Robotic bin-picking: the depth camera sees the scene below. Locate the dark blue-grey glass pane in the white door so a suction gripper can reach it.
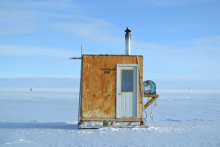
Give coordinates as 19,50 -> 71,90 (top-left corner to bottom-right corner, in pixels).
121,70 -> 134,92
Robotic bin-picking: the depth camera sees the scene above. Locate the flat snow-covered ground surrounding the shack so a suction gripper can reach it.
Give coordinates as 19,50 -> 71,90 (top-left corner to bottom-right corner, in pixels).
0,88 -> 220,147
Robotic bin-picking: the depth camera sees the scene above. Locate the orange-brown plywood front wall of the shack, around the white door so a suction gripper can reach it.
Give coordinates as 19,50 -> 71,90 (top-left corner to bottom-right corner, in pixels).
82,55 -> 143,119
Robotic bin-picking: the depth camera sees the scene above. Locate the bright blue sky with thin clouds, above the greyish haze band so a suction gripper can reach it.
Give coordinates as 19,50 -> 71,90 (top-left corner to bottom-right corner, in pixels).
0,0 -> 220,84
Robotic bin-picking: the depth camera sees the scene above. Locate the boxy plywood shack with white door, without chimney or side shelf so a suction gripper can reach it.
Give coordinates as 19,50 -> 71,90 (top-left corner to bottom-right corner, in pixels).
78,54 -> 144,128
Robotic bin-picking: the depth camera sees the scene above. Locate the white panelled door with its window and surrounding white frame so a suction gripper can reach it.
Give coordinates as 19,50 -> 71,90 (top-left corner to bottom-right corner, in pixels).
116,64 -> 139,118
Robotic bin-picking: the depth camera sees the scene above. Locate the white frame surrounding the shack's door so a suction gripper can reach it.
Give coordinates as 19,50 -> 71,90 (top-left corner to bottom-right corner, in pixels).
115,64 -> 139,118
